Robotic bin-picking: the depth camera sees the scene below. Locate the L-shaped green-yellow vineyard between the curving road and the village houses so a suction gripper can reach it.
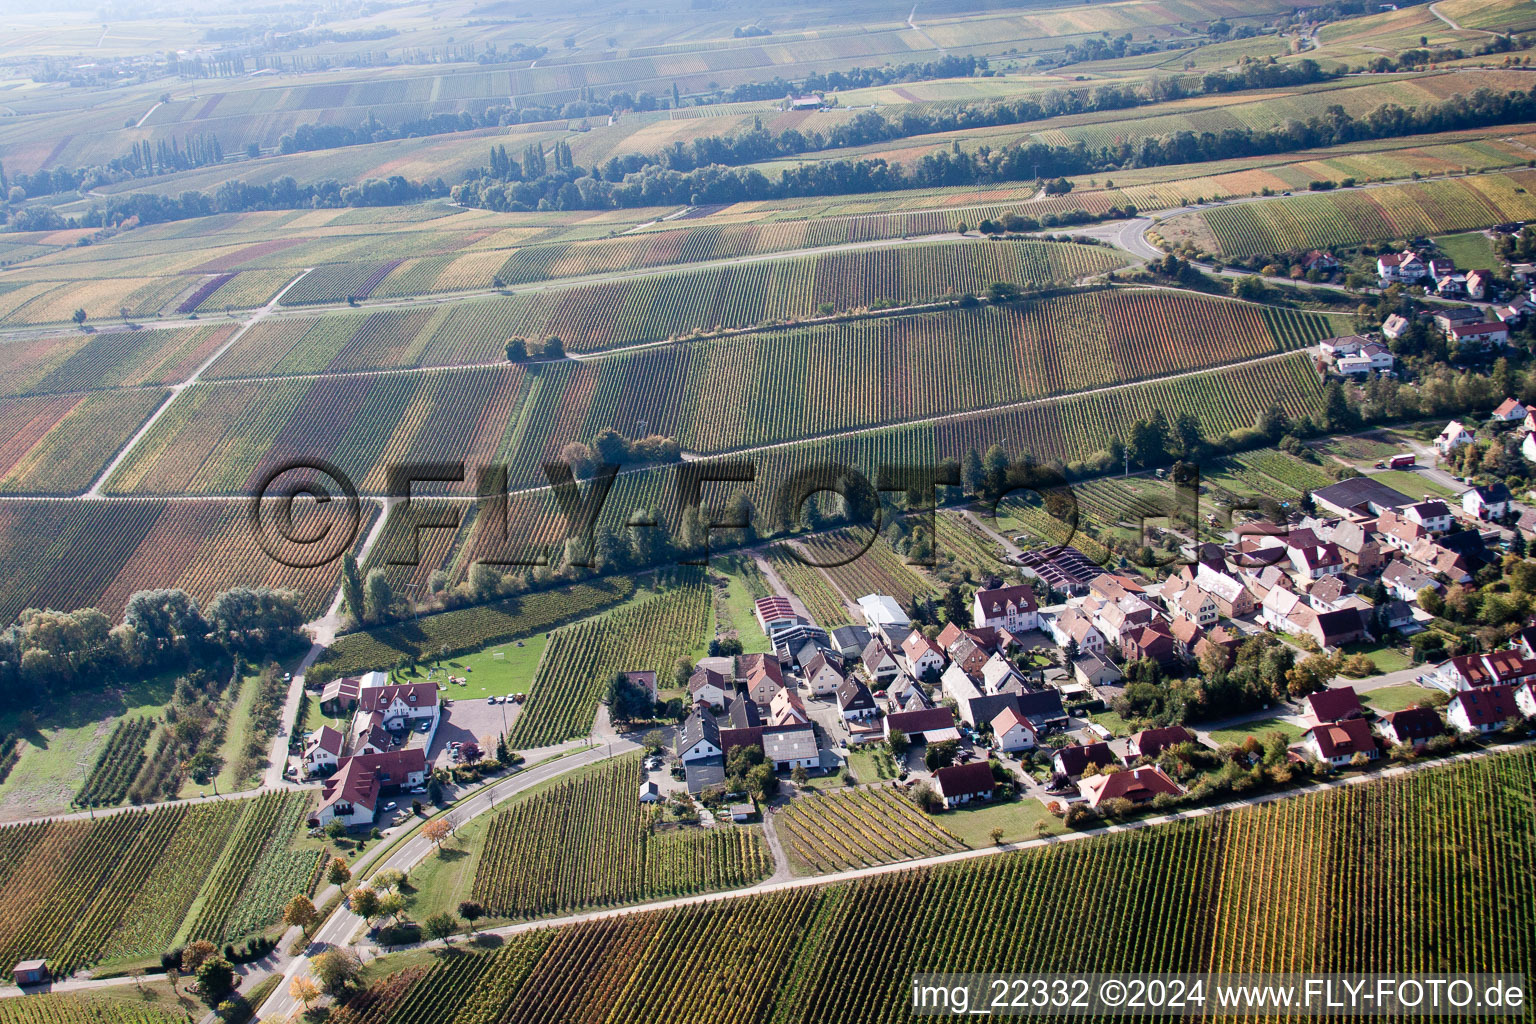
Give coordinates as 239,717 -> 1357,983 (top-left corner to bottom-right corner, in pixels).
472,755 -> 773,918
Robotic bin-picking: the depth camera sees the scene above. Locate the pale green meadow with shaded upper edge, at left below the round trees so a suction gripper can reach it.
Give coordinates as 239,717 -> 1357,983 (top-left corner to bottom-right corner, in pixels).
0,672 -> 180,820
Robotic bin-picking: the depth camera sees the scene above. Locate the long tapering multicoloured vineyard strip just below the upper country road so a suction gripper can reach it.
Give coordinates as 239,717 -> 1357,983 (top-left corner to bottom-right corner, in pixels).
209,243 -> 1124,378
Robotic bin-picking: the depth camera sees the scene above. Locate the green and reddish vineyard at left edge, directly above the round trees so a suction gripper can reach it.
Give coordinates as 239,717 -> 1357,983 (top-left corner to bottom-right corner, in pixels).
0,499 -> 378,622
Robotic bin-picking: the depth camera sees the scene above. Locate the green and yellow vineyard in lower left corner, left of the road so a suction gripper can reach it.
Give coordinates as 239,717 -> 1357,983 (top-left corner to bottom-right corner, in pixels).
0,792 -> 319,973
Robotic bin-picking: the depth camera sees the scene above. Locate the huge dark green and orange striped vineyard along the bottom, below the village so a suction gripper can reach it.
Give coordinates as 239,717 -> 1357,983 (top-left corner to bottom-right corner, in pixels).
339,751 -> 1536,1024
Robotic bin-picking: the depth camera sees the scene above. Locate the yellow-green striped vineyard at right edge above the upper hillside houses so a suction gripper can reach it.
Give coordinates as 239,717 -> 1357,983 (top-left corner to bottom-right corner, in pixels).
1158,170 -> 1536,256
